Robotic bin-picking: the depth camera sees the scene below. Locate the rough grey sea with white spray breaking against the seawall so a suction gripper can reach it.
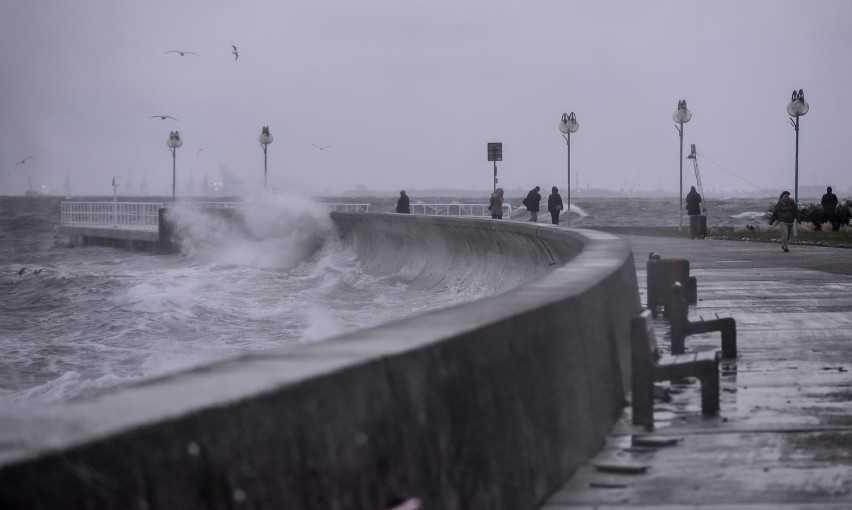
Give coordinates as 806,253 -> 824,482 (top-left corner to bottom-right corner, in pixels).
0,195 -> 773,412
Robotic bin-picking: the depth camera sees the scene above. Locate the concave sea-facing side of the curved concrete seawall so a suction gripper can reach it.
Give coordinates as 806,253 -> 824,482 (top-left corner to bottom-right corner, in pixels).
332,213 -> 583,291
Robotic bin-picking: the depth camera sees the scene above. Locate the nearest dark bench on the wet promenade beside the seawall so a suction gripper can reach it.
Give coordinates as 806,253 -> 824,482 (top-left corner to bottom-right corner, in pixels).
630,310 -> 719,429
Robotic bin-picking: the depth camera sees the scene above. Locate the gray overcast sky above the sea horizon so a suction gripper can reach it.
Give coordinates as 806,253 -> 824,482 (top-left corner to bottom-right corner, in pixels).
0,0 -> 852,196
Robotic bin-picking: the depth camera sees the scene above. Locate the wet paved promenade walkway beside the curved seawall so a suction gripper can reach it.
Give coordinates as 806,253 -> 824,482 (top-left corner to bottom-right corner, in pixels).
542,236 -> 852,510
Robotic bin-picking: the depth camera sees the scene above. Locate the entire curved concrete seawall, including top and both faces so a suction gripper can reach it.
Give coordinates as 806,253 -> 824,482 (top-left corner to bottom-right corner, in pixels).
0,213 -> 640,510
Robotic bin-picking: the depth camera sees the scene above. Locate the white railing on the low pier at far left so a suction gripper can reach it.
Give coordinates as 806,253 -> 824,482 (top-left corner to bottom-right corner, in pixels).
61,202 -> 163,230
